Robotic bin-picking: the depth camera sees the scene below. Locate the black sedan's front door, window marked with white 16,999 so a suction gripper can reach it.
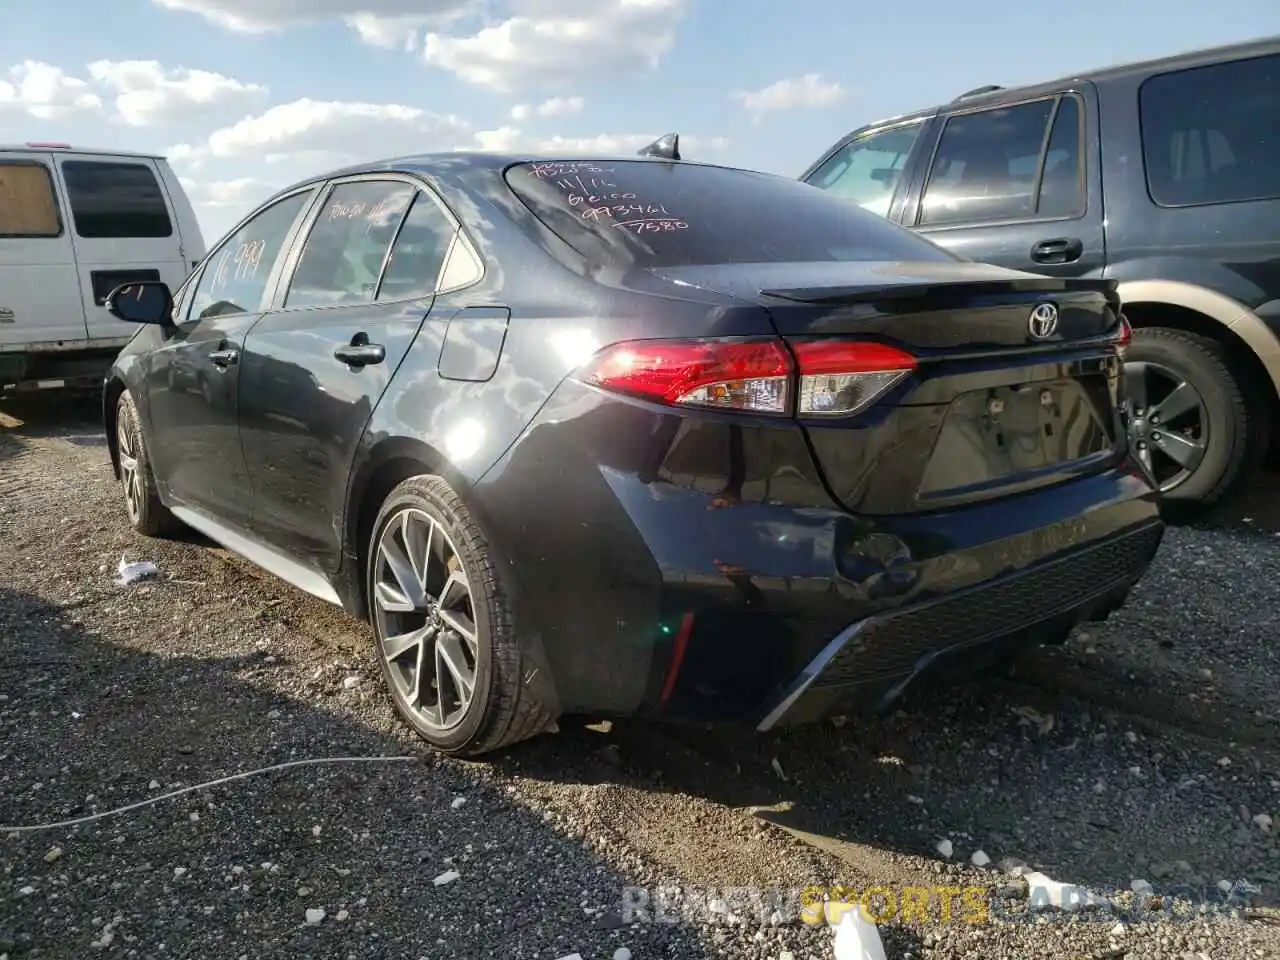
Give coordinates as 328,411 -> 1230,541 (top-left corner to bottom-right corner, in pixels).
147,189 -> 314,530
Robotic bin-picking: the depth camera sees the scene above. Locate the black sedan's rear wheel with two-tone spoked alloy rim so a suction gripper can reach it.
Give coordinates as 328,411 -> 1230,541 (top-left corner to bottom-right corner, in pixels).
366,476 -> 554,756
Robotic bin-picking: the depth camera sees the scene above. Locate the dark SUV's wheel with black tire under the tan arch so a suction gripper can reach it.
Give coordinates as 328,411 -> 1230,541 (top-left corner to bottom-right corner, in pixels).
1125,326 -> 1270,509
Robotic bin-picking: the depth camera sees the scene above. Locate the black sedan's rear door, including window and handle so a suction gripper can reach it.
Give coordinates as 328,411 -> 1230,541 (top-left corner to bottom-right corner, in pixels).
239,174 -> 456,571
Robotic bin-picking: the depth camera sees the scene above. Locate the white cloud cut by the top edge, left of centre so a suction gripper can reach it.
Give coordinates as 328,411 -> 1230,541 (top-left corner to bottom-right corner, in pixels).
152,0 -> 477,47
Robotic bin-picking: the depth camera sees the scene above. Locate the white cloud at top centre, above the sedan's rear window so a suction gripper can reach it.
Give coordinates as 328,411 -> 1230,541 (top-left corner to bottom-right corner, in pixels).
424,0 -> 687,92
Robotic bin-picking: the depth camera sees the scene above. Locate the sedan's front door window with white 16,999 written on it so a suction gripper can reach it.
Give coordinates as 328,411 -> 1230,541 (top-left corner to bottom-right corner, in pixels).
188,191 -> 311,320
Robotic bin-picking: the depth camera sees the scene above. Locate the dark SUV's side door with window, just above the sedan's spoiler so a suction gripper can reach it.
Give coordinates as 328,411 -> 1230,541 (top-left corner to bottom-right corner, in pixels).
904,83 -> 1106,276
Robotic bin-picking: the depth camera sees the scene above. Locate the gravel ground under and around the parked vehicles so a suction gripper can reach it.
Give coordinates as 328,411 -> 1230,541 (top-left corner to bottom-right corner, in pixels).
0,397 -> 1280,960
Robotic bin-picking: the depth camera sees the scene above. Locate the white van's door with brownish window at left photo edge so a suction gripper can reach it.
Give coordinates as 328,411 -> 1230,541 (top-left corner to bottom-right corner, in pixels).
0,151 -> 87,350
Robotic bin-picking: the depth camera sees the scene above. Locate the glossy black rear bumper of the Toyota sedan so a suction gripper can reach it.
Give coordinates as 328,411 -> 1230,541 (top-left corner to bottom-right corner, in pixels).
472,387 -> 1162,726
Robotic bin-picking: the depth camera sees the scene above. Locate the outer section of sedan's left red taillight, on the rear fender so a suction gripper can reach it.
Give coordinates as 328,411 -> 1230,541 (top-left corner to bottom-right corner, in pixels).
581,339 -> 791,413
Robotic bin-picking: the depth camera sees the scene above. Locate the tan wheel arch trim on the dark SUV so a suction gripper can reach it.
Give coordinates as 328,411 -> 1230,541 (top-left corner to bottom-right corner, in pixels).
1119,280 -> 1280,442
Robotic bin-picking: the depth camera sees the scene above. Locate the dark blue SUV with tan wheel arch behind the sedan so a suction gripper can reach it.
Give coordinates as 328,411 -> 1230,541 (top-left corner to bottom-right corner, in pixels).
801,38 -> 1280,506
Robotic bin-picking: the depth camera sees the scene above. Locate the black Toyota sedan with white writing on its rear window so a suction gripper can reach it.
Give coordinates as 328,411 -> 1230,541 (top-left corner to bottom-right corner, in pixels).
104,144 -> 1162,754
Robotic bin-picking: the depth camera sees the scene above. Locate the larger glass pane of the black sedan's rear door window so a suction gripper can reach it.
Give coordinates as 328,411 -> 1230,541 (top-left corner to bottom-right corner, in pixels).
284,180 -> 414,307
